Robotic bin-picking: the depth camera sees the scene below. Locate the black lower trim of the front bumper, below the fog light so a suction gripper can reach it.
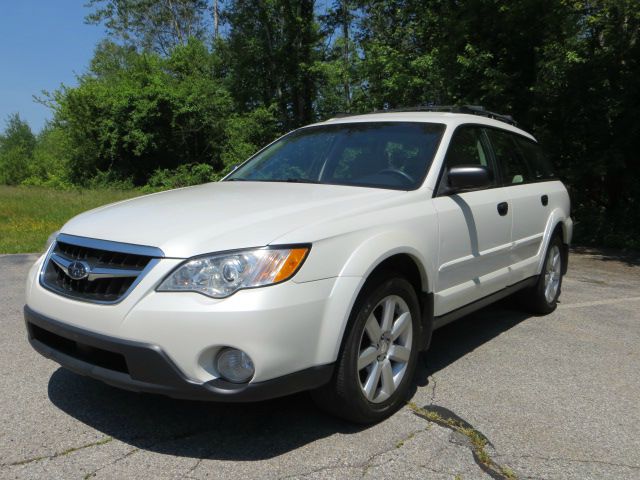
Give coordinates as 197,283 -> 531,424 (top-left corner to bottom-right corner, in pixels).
24,306 -> 334,402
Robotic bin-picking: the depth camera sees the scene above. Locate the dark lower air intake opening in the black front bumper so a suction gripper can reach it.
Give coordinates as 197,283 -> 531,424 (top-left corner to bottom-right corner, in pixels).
28,323 -> 129,374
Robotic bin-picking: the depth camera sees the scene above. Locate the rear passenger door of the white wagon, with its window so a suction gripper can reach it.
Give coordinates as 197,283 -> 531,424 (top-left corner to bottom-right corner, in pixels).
486,128 -> 550,283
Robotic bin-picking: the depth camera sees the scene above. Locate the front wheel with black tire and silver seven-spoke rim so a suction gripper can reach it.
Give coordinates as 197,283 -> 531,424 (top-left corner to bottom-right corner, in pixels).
312,273 -> 420,424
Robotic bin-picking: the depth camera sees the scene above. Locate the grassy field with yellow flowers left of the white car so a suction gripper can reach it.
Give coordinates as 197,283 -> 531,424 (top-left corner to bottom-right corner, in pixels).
0,185 -> 142,254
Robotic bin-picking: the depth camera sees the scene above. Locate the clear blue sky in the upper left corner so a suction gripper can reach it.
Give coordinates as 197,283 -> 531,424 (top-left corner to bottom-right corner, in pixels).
0,0 -> 104,132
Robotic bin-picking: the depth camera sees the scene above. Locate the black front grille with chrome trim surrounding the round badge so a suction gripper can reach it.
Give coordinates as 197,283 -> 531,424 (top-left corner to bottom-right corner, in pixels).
41,235 -> 162,303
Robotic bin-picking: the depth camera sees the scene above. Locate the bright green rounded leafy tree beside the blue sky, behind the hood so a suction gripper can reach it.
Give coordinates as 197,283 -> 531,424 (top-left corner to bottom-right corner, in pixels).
50,40 -> 232,185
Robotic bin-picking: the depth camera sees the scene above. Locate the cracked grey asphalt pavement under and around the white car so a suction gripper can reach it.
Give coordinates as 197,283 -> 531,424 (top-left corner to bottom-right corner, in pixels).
0,251 -> 640,480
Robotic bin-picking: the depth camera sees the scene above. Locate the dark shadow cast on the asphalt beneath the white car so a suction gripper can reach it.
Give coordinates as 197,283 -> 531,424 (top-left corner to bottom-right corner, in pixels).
48,298 -> 527,460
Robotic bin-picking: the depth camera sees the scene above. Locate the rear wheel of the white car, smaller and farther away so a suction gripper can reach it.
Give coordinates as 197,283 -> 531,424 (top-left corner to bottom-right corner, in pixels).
521,234 -> 564,315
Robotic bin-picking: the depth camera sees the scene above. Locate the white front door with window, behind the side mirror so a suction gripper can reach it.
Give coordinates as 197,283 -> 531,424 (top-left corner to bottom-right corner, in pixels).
433,125 -> 511,316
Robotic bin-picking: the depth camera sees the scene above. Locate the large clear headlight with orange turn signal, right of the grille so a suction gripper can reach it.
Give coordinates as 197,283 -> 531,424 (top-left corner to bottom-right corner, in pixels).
157,247 -> 309,298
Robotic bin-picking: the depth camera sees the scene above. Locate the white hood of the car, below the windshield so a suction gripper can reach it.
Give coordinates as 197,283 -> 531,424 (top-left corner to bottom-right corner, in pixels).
61,182 -> 406,258
